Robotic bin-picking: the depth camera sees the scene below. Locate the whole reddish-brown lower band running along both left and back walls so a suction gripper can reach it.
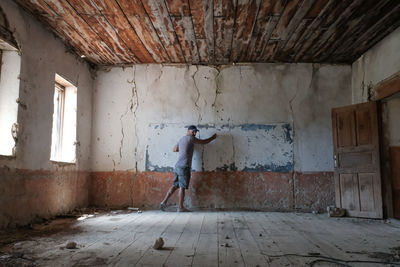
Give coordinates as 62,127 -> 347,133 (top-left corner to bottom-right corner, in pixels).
0,169 -> 334,228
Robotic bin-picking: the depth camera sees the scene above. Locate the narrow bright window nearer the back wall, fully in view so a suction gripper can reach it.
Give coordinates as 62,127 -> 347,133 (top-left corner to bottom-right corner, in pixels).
50,74 -> 77,163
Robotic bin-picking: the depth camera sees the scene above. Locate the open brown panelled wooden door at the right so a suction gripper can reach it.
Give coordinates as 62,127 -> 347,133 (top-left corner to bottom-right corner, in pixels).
332,102 -> 383,218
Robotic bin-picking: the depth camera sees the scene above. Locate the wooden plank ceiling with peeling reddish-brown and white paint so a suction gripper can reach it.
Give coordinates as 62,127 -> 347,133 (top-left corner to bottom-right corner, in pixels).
15,0 -> 400,65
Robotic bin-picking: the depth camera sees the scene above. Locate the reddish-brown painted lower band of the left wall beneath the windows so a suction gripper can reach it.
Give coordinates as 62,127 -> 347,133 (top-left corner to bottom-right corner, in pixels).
0,169 -> 89,228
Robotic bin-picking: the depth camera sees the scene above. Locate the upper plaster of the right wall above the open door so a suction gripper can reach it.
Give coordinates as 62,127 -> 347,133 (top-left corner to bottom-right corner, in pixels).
352,28 -> 400,104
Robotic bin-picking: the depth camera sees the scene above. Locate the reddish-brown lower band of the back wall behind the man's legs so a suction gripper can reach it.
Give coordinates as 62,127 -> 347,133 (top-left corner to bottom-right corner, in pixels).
89,171 -> 335,214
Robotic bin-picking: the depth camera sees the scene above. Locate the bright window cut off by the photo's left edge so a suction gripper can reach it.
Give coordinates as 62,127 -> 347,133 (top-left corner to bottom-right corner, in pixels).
0,39 -> 21,156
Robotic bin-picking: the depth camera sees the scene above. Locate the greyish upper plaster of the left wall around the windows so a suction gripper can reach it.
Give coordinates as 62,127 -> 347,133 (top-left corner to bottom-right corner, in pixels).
0,0 -> 93,170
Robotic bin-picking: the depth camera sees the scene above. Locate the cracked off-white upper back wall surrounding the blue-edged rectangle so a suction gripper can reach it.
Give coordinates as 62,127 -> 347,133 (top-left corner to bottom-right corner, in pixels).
91,64 -> 351,172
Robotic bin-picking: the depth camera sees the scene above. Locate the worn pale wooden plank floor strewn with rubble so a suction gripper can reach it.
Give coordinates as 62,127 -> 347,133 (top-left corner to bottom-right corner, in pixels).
0,211 -> 400,266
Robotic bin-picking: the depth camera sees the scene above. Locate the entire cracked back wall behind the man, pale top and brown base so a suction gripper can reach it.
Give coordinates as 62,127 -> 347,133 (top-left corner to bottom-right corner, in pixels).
90,64 -> 351,213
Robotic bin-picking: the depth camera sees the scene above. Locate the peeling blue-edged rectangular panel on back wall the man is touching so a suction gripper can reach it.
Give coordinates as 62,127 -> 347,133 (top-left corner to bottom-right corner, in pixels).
145,123 -> 293,172
